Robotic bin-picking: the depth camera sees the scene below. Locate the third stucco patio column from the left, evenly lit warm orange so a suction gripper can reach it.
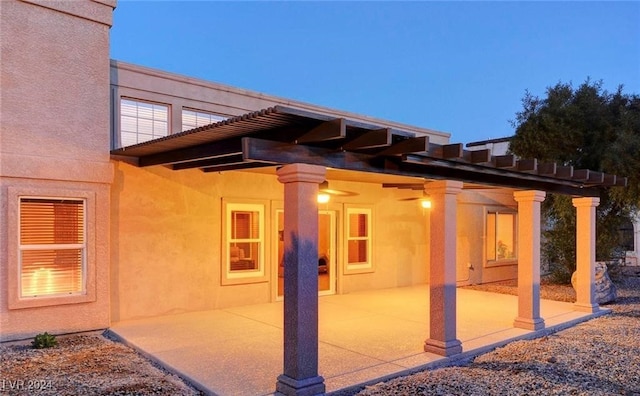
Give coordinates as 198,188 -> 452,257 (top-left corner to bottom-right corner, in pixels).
513,191 -> 546,330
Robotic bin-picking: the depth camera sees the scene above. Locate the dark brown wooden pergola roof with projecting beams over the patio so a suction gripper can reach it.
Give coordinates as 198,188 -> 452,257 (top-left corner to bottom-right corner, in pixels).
111,105 -> 626,196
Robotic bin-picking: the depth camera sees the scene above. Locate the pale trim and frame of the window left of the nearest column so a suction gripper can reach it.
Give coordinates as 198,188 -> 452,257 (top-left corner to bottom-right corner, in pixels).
220,199 -> 269,286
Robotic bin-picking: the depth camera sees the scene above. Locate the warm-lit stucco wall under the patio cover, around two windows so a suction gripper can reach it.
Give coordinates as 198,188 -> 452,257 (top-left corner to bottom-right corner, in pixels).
111,162 -> 436,321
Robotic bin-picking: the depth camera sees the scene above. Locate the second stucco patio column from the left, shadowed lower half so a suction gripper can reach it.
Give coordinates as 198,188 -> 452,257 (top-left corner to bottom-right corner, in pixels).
424,180 -> 462,356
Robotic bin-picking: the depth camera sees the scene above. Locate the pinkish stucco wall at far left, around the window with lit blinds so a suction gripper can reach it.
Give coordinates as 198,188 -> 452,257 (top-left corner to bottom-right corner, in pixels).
0,0 -> 115,340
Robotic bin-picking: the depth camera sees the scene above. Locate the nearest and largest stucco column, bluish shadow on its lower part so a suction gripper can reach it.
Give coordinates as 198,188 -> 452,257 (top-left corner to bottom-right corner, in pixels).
276,164 -> 326,396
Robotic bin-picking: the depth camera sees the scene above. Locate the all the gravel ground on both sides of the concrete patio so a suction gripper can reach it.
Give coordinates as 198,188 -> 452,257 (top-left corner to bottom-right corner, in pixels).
0,271 -> 640,396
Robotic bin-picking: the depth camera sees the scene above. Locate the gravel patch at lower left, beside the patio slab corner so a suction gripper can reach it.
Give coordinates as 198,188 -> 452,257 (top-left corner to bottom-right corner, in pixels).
0,334 -> 200,396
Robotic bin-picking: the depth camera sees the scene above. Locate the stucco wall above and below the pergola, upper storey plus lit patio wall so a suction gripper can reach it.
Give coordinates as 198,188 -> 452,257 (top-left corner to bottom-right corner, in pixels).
110,60 -> 460,321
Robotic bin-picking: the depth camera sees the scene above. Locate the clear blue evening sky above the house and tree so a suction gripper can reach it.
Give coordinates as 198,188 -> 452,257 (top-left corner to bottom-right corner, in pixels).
111,0 -> 640,143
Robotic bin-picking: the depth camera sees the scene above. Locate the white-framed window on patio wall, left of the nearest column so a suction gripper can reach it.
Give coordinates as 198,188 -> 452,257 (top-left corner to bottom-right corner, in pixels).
223,203 -> 265,283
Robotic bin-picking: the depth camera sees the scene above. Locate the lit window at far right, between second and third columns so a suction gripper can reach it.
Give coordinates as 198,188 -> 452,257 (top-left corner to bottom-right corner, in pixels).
487,212 -> 517,261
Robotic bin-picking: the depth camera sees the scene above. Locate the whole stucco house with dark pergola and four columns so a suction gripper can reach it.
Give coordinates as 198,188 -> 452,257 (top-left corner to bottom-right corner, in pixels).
0,0 -> 621,394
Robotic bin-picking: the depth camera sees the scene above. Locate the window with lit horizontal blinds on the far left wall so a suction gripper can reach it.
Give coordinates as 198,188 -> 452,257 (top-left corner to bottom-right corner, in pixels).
19,197 -> 86,298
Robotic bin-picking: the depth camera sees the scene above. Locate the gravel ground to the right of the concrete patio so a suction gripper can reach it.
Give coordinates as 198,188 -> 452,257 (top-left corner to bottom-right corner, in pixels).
358,272 -> 640,396
